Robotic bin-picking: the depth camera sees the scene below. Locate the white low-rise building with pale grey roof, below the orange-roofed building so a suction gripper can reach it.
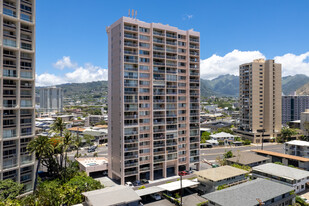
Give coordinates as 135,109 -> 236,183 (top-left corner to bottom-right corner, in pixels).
252,163 -> 309,193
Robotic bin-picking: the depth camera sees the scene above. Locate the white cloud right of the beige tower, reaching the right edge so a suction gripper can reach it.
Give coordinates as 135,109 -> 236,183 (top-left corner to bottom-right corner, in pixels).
274,52 -> 309,76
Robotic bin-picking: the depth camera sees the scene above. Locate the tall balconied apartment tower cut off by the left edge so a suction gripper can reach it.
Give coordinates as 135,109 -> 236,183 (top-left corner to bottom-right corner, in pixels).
0,0 -> 35,193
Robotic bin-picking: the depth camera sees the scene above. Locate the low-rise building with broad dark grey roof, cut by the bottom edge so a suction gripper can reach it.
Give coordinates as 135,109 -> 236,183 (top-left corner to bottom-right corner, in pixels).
202,179 -> 295,206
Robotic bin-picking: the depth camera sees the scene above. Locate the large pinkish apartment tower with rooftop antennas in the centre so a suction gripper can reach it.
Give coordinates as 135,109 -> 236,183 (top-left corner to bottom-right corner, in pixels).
107,17 -> 200,184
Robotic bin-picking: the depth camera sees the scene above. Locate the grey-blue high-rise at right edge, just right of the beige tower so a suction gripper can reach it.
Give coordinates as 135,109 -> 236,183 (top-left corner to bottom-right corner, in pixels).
282,95 -> 309,124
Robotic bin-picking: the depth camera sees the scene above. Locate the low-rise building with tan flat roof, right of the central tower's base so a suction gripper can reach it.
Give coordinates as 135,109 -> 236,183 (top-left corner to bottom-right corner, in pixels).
195,166 -> 248,193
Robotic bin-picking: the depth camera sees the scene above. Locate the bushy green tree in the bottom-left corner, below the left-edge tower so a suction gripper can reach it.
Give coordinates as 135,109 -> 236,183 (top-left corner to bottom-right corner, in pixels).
0,179 -> 23,202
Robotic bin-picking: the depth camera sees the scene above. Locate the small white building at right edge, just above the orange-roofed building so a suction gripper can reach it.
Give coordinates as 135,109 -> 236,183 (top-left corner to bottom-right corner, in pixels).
284,140 -> 309,158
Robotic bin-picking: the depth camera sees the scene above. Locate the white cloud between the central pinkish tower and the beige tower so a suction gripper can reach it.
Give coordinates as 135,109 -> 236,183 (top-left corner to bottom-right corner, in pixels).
200,49 -> 265,79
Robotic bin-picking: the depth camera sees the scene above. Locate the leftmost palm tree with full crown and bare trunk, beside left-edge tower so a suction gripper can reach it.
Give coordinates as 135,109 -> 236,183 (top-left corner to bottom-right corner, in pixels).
27,136 -> 53,192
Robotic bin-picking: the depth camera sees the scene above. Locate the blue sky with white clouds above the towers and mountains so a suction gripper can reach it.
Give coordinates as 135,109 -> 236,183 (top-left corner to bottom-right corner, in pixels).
36,0 -> 309,85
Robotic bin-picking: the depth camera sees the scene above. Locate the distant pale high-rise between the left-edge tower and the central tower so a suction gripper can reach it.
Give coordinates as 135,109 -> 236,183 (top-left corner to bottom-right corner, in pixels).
40,87 -> 63,112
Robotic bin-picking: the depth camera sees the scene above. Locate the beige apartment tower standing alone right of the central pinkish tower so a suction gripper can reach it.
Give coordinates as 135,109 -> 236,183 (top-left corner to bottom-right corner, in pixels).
237,59 -> 282,143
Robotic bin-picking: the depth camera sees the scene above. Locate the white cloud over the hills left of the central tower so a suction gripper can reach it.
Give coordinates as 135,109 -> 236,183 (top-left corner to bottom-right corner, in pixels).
36,57 -> 108,86
